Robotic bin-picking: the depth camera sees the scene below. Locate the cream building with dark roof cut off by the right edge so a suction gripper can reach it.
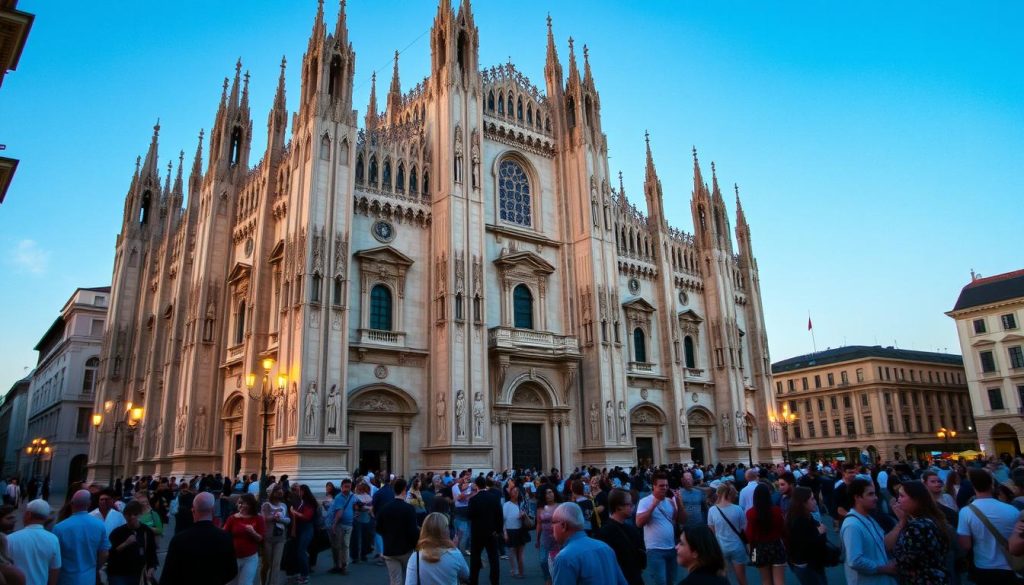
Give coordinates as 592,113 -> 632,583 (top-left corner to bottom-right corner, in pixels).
946,270 -> 1024,455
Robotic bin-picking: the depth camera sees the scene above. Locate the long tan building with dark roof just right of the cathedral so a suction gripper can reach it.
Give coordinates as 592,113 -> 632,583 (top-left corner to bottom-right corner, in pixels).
772,345 -> 978,461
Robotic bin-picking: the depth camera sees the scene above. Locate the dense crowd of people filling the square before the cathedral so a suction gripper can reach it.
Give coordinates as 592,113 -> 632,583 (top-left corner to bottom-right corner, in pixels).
6,458 -> 1024,585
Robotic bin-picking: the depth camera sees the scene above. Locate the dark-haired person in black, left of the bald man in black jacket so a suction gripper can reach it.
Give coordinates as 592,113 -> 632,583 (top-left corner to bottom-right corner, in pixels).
106,501 -> 158,585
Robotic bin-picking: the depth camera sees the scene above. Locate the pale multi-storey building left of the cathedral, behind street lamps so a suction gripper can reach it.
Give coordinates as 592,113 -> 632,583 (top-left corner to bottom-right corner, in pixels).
22,287 -> 111,494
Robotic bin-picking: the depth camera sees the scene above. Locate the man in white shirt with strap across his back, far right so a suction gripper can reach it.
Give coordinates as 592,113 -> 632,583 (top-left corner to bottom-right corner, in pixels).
956,469 -> 1021,585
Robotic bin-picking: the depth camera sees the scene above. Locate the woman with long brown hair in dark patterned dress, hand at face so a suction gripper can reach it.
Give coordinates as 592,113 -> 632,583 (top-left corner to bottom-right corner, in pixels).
886,480 -> 950,585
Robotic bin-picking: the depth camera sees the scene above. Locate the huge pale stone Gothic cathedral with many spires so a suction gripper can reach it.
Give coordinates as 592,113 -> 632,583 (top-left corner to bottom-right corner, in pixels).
89,0 -> 782,485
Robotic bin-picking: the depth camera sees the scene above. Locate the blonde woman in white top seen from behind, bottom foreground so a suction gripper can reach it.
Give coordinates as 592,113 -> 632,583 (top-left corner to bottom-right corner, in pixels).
406,512 -> 469,585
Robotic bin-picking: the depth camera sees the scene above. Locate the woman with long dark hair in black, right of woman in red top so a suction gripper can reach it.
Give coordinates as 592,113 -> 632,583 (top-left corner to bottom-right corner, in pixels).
785,486 -> 828,585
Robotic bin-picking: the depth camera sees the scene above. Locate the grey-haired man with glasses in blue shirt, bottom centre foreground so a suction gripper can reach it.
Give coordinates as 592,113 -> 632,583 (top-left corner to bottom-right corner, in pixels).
551,502 -> 627,585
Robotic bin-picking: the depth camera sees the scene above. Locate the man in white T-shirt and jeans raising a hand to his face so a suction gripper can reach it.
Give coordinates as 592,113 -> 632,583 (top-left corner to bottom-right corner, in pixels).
636,471 -> 686,585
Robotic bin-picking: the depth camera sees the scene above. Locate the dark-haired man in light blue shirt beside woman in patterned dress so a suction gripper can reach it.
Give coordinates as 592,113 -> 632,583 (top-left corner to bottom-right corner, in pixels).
836,477 -> 896,585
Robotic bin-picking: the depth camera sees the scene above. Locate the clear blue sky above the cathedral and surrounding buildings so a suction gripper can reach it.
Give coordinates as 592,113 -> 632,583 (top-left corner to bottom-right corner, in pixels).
0,0 -> 1024,391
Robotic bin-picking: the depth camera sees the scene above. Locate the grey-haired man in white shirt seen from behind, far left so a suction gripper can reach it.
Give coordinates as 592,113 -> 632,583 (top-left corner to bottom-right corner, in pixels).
7,500 -> 60,585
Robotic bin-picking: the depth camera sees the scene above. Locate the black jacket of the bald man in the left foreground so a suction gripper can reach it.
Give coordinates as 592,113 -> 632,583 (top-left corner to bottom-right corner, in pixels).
160,520 -> 239,585
